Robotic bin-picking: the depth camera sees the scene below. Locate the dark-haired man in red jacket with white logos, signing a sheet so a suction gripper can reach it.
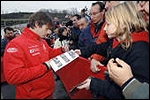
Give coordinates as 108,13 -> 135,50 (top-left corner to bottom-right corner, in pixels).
4,11 -> 67,99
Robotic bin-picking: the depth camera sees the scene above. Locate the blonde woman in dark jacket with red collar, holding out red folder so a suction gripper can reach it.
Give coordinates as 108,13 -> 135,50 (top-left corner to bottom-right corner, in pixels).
76,2 -> 149,99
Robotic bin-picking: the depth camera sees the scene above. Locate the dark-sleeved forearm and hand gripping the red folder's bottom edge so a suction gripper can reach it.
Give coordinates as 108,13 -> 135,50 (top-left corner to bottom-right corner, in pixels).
77,77 -> 124,99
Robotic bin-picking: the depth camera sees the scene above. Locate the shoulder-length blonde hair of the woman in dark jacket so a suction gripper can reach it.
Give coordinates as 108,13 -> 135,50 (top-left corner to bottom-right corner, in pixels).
105,1 -> 147,49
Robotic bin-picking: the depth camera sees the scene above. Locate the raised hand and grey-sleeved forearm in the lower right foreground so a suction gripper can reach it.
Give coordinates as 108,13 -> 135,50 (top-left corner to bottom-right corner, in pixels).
107,58 -> 149,99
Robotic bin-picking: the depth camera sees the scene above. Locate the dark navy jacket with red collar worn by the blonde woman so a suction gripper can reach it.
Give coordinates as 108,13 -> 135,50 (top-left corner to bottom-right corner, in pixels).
81,32 -> 149,99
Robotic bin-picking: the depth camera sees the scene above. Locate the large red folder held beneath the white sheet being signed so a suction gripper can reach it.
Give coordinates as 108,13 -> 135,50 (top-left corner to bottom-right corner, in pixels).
56,57 -> 106,99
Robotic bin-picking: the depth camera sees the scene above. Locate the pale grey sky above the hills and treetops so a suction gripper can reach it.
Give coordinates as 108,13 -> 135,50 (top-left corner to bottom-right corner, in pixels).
1,1 -> 95,13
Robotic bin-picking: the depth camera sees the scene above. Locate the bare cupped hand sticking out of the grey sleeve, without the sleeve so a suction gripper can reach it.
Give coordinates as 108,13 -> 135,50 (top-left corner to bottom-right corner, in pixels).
107,58 -> 133,86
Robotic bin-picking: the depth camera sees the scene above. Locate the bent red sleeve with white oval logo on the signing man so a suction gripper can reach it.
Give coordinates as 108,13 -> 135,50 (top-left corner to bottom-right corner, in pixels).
3,42 -> 47,84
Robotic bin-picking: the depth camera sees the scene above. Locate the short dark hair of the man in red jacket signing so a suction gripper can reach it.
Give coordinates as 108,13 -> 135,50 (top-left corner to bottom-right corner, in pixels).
27,11 -> 53,28
